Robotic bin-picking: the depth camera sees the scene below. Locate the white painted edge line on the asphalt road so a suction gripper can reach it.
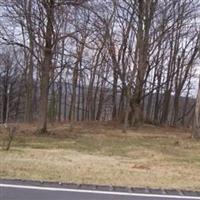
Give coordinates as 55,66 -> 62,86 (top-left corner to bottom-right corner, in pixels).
0,184 -> 200,200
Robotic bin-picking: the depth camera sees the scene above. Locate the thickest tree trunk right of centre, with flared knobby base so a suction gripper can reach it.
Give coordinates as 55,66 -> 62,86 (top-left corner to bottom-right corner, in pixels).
129,0 -> 157,125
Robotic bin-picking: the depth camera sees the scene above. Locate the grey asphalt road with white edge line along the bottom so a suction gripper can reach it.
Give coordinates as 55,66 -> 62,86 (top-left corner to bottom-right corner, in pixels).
0,181 -> 200,200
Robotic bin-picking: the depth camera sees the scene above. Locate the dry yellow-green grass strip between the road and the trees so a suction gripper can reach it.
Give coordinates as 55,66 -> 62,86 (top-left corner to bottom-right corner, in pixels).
0,123 -> 200,190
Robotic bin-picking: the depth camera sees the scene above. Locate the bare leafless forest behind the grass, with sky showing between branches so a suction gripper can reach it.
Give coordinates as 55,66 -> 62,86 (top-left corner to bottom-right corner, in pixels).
0,0 -> 200,138
